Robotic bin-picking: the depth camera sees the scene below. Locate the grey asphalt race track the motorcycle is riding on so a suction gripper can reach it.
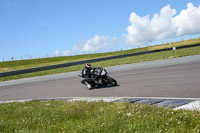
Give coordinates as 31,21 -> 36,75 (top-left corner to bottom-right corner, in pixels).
0,55 -> 200,101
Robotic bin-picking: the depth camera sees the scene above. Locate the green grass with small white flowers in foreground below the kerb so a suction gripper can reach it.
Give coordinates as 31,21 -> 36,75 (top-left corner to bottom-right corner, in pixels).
0,101 -> 200,133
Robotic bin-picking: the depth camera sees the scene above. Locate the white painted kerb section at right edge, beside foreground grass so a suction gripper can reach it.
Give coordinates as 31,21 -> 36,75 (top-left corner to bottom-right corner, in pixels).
174,101 -> 200,110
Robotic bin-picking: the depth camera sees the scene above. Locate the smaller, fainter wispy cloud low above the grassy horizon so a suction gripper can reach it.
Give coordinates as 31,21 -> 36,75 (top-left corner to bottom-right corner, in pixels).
55,35 -> 117,56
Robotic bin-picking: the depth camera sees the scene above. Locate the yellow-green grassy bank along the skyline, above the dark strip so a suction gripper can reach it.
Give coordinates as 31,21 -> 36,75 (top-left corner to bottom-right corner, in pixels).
0,38 -> 200,72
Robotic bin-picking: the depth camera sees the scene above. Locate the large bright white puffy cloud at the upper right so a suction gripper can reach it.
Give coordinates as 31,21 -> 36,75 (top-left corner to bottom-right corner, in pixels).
125,3 -> 200,45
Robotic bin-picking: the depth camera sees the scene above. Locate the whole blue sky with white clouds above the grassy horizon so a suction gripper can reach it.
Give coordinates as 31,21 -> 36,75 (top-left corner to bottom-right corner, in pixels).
0,0 -> 200,62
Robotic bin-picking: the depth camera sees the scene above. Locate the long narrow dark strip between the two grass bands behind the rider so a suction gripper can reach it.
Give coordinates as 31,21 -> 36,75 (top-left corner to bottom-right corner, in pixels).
0,44 -> 200,77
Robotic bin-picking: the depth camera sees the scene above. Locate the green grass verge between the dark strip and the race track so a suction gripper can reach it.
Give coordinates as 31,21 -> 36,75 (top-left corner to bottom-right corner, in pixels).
0,47 -> 200,81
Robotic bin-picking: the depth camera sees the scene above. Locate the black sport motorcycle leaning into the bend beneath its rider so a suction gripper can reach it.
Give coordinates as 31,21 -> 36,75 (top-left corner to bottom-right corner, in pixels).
79,67 -> 117,88
